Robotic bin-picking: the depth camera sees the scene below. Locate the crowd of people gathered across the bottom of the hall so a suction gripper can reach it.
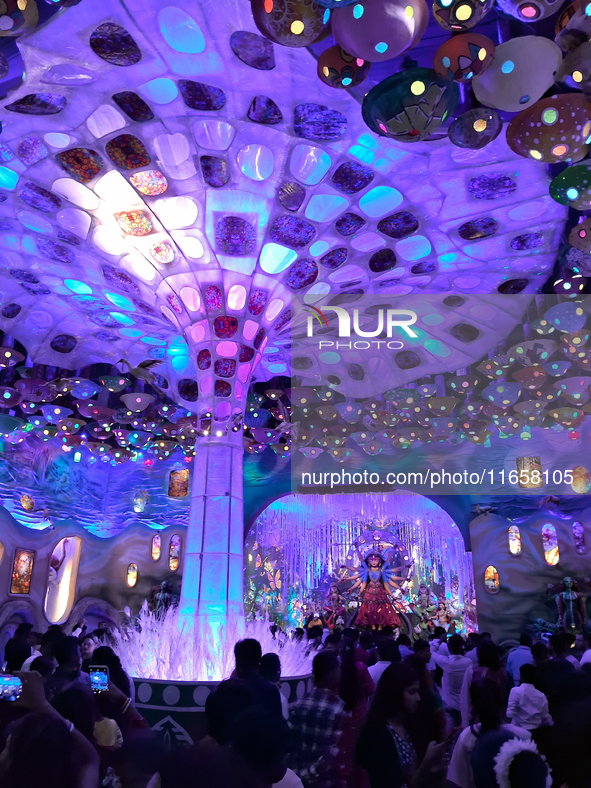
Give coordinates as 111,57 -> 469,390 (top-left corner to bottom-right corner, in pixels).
0,625 -> 591,788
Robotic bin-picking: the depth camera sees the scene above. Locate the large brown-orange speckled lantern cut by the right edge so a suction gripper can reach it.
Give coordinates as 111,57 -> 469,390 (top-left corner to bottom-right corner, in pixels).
506,93 -> 591,164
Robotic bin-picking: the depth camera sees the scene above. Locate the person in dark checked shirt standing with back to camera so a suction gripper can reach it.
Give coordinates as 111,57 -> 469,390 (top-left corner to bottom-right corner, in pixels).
288,651 -> 350,788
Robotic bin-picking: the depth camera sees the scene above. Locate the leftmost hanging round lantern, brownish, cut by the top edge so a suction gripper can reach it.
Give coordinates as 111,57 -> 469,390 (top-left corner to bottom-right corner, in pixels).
250,0 -> 332,47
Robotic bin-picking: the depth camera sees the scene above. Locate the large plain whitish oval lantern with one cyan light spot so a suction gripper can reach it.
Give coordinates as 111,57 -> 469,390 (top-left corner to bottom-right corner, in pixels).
472,36 -> 562,112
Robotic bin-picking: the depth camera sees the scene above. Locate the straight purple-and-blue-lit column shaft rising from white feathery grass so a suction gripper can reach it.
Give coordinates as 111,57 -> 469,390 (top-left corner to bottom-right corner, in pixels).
180,425 -> 244,624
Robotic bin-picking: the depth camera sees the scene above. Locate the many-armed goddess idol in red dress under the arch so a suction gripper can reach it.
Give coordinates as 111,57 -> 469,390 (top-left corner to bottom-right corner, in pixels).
339,530 -> 412,630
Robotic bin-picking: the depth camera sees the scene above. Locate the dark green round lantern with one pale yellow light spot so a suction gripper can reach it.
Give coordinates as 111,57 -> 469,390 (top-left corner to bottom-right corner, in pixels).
362,68 -> 459,142
